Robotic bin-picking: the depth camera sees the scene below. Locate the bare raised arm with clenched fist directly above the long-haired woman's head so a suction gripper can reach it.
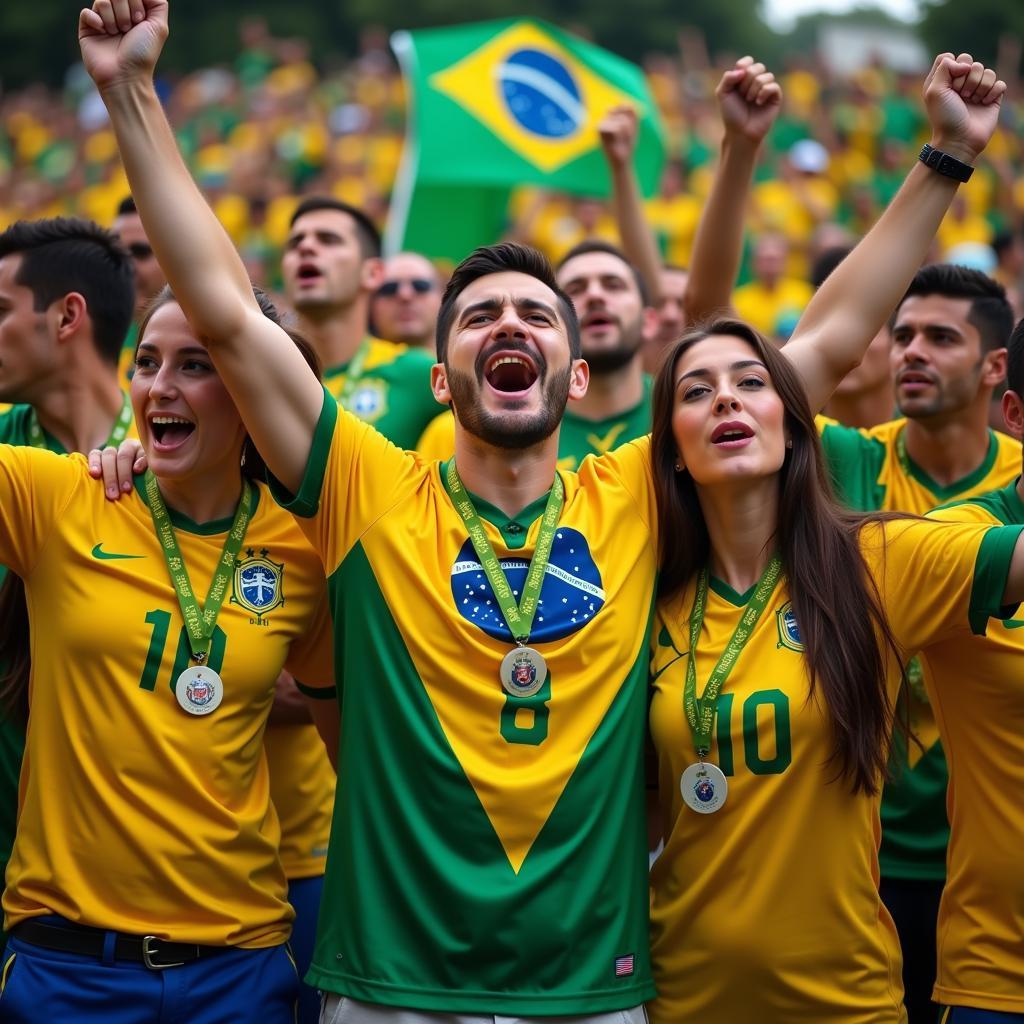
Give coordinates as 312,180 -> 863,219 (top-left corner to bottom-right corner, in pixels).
683,56 -> 782,323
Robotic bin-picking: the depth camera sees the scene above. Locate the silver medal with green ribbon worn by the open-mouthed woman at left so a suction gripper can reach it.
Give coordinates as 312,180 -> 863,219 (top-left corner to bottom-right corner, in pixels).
144,469 -> 253,715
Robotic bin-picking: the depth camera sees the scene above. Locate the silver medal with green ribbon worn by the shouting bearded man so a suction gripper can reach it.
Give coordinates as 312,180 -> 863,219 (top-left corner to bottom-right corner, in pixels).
446,459 -> 565,697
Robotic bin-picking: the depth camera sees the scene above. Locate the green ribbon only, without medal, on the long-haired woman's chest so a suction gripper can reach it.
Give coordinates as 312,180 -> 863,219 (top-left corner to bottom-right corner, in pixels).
683,555 -> 782,761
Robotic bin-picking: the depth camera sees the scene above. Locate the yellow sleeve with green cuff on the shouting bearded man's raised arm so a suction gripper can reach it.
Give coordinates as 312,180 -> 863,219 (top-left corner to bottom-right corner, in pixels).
270,388 -> 426,575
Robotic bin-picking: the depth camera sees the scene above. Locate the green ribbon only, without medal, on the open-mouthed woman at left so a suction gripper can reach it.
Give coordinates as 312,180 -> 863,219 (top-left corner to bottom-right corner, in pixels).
145,469 -> 253,665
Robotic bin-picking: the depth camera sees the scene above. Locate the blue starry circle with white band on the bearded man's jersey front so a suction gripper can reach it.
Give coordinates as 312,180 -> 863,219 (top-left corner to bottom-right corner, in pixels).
452,526 -> 604,643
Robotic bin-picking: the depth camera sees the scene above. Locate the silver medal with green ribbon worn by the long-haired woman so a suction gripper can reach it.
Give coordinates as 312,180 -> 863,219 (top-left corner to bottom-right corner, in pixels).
679,555 -> 782,814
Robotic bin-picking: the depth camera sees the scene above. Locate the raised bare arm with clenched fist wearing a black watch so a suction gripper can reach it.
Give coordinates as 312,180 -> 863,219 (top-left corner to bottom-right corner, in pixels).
783,53 -> 1007,412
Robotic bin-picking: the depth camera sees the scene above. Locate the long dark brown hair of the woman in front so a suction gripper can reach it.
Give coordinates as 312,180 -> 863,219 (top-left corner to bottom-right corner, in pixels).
651,318 -> 904,795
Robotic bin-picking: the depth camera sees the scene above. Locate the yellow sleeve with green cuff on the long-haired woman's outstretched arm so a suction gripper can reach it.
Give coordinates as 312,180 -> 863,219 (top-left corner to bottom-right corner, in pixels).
862,519 -> 1024,654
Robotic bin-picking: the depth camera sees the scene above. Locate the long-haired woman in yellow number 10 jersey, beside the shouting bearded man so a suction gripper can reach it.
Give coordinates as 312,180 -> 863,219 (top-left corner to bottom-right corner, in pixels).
650,319 -> 1024,1024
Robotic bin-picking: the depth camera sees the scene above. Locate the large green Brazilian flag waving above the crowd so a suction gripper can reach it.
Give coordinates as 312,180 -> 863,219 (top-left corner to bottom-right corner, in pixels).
385,18 -> 665,261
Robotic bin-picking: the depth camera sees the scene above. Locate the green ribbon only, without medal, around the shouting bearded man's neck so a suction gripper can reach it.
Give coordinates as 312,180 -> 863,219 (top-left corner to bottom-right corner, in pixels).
447,459 -> 565,647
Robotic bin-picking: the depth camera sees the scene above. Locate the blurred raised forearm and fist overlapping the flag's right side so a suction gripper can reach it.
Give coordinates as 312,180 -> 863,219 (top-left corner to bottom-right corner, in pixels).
597,105 -> 662,306
